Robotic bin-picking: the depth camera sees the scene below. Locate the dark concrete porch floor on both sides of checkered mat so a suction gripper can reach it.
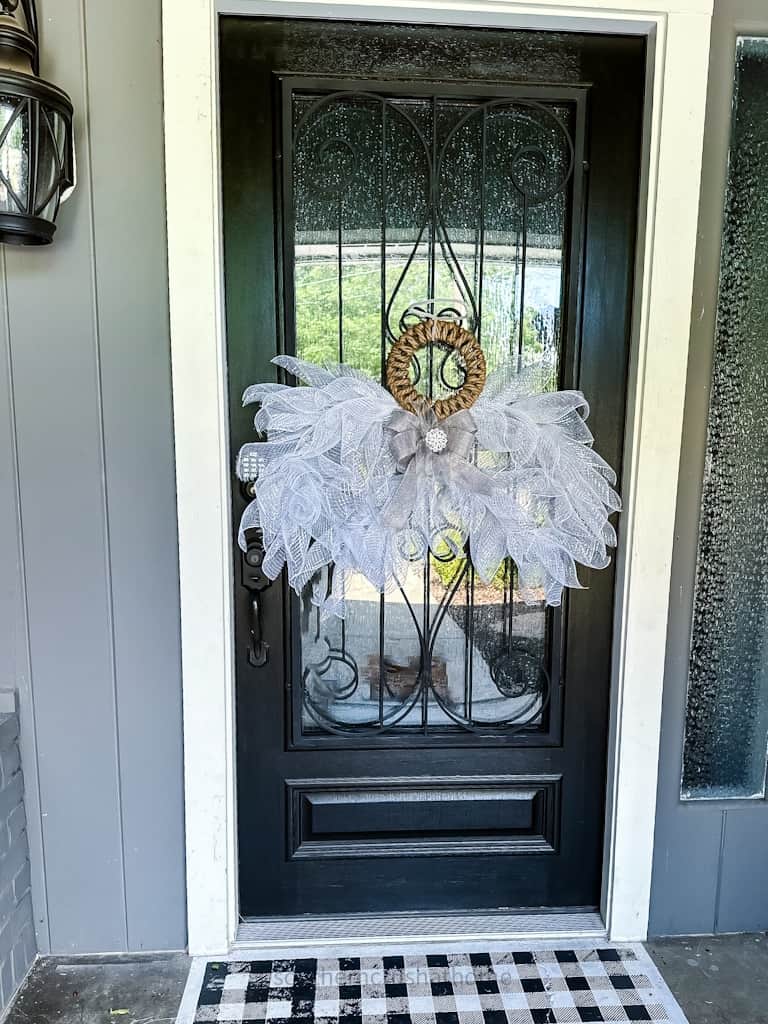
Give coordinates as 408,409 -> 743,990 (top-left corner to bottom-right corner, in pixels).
5,934 -> 768,1024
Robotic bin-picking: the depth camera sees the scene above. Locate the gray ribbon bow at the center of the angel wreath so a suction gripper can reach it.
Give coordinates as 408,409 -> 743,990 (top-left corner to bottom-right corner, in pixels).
384,404 -> 494,528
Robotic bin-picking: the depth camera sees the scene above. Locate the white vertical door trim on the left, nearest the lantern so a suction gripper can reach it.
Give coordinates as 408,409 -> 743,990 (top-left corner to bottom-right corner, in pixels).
163,0 -> 237,954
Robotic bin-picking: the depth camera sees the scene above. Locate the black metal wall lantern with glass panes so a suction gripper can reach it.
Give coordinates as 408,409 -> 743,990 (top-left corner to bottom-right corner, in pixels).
0,0 -> 75,246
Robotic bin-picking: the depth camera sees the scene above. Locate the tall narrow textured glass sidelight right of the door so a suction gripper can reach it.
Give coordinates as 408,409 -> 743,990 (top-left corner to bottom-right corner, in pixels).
682,38 -> 768,800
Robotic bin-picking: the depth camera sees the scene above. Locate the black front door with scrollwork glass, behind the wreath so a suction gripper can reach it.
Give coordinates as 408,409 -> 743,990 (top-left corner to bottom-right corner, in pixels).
221,18 -> 644,915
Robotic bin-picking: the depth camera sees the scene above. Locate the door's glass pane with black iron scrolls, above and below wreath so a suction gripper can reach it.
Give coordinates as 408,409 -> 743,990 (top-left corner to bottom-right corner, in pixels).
288,83 -> 574,736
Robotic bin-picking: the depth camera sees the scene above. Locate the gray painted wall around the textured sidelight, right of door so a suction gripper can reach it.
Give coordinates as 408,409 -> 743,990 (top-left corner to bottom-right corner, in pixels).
650,0 -> 768,935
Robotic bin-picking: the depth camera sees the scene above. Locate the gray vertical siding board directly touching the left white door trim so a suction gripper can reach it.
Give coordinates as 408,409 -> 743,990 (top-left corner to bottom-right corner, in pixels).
86,0 -> 185,949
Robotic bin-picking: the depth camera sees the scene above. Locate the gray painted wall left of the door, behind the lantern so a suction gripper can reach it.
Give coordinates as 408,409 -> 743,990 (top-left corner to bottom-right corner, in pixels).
0,0 -> 186,952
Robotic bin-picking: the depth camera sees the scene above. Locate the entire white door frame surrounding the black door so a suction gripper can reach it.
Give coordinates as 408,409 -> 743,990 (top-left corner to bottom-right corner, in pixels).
163,0 -> 713,955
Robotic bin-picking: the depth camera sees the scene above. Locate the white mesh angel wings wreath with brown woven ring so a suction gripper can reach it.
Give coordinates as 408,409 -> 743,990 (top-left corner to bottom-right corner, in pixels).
238,304 -> 621,618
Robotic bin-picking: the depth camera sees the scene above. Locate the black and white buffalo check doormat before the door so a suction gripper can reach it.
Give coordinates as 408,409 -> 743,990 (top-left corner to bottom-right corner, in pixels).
178,945 -> 685,1024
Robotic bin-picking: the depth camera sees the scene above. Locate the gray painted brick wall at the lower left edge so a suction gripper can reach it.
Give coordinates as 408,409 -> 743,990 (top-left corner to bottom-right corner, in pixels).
0,714 -> 37,1011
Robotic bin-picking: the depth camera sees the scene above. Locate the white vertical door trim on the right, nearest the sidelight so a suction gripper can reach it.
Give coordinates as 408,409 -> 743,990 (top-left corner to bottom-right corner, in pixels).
604,5 -> 711,941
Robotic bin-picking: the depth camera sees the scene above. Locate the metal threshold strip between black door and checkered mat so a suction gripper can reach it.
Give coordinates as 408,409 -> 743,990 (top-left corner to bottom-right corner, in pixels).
232,911 -> 606,951
